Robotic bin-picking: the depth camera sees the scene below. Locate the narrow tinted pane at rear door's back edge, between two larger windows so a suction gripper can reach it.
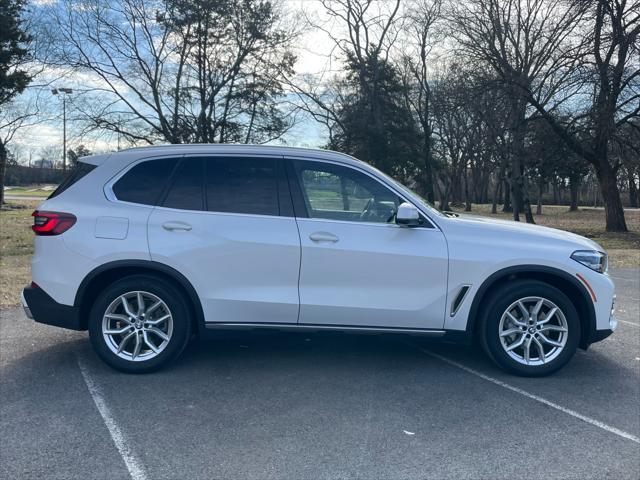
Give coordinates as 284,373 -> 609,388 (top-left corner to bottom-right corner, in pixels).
162,158 -> 204,210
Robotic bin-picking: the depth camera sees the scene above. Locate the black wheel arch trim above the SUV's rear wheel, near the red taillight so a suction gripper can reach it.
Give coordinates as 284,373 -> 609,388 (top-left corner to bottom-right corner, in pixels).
74,260 -> 204,332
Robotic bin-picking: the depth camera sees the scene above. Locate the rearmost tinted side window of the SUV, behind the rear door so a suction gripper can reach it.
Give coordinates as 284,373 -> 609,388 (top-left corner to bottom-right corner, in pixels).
113,158 -> 177,205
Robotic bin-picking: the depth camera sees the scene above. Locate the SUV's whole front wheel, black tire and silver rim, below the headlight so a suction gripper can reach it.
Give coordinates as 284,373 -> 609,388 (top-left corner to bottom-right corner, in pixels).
480,280 -> 580,377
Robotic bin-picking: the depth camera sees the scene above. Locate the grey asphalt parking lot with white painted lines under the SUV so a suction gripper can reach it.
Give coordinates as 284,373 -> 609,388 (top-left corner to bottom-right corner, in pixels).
0,269 -> 640,479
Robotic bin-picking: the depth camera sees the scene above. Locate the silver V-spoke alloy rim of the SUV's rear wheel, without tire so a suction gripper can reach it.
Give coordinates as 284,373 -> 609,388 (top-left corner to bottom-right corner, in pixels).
102,291 -> 173,362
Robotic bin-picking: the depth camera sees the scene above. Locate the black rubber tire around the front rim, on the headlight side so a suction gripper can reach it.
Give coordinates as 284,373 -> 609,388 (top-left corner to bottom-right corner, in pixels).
478,280 -> 580,377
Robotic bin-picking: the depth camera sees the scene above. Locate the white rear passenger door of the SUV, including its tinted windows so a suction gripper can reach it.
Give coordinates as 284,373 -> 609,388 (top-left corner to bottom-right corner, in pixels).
148,156 -> 300,323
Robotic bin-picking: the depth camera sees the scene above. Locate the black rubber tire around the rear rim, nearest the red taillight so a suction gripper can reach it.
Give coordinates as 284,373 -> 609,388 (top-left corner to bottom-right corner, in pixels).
88,275 -> 192,373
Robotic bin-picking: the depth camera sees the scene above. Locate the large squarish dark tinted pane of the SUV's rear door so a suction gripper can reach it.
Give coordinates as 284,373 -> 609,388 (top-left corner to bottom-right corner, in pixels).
205,158 -> 279,215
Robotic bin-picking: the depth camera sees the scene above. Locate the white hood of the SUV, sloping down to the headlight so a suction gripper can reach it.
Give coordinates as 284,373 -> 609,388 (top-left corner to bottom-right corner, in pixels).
449,214 -> 605,252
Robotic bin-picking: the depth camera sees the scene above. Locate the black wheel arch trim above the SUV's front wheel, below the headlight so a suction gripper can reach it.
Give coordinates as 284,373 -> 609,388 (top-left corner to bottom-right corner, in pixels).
467,265 -> 596,349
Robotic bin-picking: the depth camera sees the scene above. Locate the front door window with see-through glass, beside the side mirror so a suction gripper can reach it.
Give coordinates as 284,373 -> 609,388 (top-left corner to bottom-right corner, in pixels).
294,161 -> 401,223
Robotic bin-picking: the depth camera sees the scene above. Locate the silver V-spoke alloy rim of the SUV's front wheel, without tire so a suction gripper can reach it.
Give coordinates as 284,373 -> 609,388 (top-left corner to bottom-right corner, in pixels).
498,297 -> 569,366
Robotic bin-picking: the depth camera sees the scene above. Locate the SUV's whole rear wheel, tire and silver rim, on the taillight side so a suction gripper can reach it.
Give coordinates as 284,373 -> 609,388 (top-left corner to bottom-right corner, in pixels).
89,275 -> 191,373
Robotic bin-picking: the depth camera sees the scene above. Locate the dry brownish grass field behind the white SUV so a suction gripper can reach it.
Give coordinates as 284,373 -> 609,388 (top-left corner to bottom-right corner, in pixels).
0,200 -> 640,305
